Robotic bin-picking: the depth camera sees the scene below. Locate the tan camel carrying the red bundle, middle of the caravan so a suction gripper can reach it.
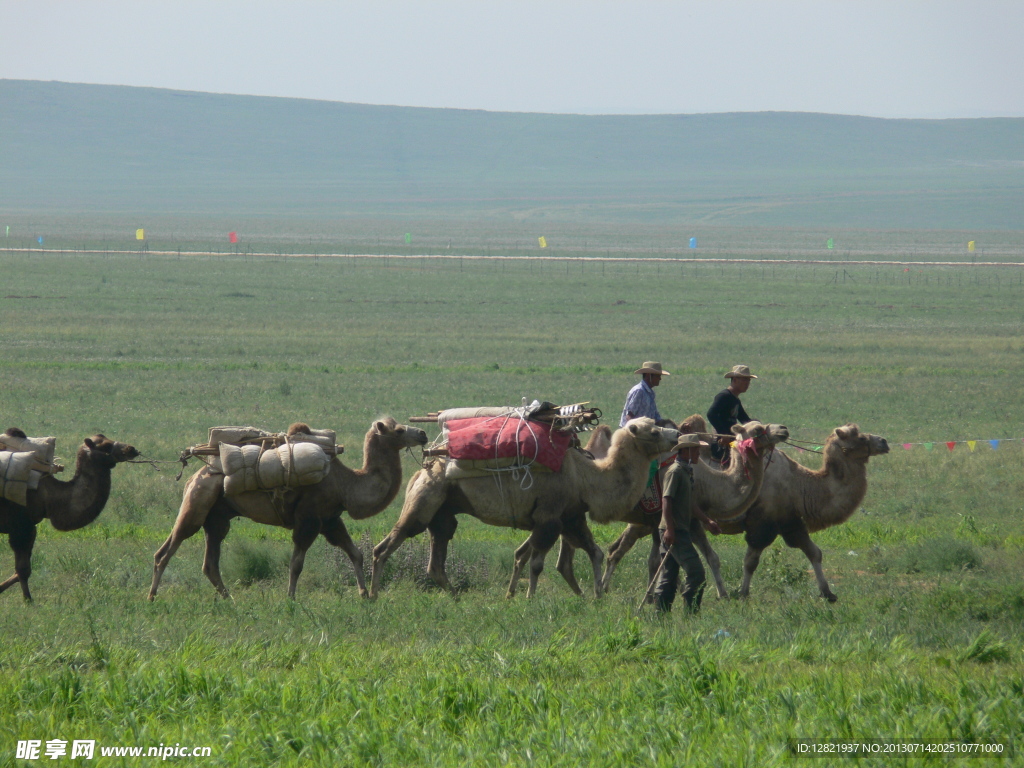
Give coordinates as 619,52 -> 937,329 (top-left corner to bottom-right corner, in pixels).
370,418 -> 679,597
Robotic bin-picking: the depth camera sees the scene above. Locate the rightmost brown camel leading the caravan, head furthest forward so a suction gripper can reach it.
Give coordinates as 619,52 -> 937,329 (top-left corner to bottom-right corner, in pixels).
612,424 -> 889,602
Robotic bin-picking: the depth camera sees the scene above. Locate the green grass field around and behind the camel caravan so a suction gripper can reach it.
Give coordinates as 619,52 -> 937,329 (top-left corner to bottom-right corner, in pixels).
0,237 -> 1024,766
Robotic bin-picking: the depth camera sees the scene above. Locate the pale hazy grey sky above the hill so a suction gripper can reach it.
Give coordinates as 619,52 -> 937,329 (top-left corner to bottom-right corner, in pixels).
0,0 -> 1024,118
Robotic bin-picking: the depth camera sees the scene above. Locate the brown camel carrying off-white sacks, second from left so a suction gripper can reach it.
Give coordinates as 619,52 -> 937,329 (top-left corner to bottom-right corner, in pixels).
150,417 -> 427,600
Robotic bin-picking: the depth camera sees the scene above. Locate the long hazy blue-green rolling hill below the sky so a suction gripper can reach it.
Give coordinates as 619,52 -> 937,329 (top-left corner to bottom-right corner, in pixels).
0,80 -> 1024,229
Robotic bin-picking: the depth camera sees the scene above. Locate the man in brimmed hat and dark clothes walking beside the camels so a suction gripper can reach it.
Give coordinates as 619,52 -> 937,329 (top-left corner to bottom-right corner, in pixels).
654,434 -> 722,613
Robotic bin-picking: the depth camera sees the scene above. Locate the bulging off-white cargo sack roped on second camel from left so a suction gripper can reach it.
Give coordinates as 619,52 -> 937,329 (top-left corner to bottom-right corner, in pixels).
219,442 -> 331,496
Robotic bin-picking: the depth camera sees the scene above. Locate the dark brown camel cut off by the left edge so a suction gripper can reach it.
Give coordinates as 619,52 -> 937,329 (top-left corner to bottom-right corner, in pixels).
0,434 -> 139,601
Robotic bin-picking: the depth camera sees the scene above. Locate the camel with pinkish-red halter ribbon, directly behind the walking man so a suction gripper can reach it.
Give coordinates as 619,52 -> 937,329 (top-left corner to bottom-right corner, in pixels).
548,415 -> 790,597
